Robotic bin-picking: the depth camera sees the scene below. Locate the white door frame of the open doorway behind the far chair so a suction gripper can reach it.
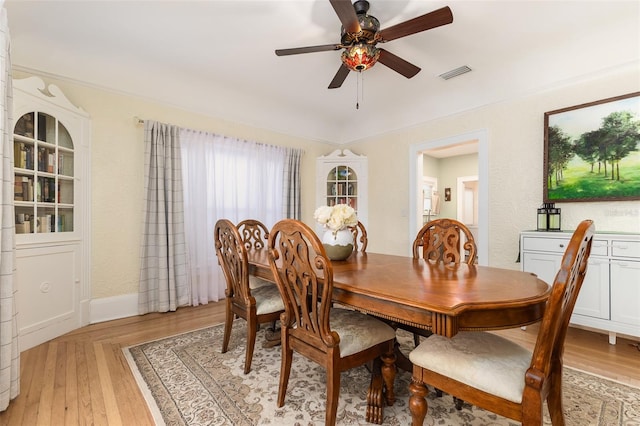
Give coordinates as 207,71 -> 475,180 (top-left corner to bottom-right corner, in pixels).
409,130 -> 489,265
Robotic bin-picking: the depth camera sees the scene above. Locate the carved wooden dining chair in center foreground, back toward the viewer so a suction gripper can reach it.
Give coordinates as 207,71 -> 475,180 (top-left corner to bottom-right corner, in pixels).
268,219 -> 395,425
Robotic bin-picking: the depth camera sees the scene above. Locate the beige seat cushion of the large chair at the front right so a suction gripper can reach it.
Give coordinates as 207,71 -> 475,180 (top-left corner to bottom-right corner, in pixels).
409,331 -> 532,403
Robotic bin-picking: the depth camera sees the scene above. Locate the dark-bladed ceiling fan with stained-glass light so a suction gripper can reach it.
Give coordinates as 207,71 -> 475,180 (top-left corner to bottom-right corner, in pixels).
276,0 -> 453,89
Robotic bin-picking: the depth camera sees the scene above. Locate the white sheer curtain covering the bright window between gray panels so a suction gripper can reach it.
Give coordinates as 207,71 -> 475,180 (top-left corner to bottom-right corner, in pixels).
180,129 -> 289,306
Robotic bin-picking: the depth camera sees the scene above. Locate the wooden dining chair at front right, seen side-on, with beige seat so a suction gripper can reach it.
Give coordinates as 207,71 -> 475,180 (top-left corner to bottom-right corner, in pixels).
409,220 -> 595,426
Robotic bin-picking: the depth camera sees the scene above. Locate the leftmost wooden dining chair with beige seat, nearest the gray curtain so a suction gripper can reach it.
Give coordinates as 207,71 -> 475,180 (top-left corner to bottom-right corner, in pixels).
214,219 -> 284,374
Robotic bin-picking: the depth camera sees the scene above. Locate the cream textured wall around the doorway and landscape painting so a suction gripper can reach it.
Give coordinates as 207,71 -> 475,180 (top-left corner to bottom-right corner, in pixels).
349,65 -> 640,269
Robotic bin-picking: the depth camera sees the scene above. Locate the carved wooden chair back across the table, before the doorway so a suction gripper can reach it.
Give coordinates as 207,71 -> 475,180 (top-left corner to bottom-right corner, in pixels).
413,219 -> 477,265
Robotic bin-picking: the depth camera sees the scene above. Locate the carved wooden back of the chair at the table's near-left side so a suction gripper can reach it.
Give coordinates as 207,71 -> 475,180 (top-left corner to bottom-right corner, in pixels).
269,219 -> 340,352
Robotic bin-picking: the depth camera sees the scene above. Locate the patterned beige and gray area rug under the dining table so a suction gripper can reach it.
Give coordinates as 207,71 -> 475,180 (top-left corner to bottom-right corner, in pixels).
124,320 -> 640,426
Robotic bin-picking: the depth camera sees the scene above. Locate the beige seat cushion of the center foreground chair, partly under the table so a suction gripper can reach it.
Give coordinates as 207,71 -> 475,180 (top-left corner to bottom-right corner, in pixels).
329,308 -> 396,358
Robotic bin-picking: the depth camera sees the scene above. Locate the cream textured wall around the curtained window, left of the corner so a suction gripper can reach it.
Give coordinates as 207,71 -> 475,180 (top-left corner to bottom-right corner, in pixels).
14,72 -> 335,299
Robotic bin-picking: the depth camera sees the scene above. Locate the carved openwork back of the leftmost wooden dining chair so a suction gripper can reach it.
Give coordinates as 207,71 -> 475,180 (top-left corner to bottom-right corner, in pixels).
214,219 -> 255,304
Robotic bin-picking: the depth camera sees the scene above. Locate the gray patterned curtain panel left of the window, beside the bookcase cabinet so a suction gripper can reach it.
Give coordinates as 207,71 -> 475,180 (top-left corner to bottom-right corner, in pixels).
138,121 -> 189,314
